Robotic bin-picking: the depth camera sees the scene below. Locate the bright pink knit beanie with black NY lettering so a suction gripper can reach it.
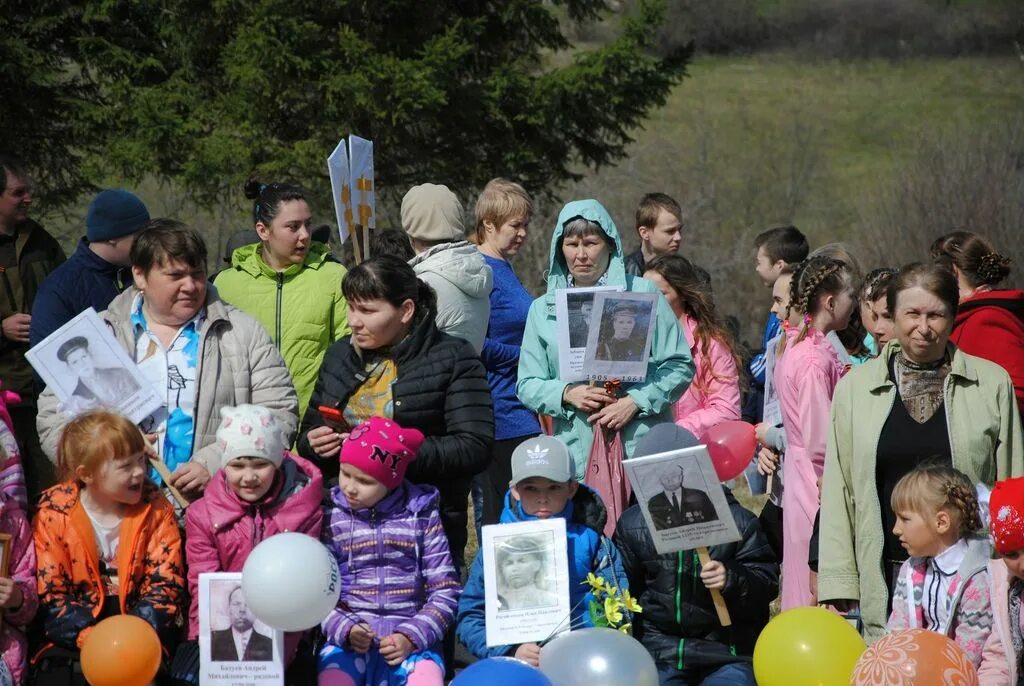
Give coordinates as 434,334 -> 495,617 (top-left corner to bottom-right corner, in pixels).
341,417 -> 423,490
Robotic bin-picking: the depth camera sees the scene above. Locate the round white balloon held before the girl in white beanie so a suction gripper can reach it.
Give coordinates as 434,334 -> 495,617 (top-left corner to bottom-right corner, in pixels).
242,533 -> 341,631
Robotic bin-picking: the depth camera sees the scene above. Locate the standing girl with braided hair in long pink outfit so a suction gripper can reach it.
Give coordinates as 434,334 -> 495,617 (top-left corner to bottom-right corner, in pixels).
774,257 -> 856,610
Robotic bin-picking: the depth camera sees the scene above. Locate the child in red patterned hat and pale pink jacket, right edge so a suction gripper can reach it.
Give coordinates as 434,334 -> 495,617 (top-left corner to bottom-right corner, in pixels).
978,477 -> 1024,686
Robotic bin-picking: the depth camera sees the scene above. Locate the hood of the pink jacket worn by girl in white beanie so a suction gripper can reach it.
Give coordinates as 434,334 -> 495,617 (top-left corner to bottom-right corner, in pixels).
203,453 -> 324,530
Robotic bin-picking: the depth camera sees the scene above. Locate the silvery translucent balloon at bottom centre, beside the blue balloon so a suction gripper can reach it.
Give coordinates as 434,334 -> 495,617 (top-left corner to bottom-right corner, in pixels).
541,629 -> 657,686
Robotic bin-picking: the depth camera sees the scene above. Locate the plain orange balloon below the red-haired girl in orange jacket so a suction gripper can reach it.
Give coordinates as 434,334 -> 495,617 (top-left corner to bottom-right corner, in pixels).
82,614 -> 161,686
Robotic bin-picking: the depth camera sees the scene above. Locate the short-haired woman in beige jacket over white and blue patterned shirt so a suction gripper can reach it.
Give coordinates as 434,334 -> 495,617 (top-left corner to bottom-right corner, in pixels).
37,220 -> 298,499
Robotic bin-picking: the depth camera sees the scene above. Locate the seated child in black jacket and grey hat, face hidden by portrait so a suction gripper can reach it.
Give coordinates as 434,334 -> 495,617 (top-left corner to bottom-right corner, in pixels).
614,424 -> 778,686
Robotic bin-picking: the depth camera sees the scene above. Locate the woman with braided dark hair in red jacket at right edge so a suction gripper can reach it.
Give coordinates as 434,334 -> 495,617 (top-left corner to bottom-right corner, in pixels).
932,231 -> 1024,410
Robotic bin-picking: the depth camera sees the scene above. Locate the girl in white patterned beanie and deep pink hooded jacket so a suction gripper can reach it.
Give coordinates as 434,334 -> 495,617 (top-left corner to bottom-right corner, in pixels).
185,404 -> 324,664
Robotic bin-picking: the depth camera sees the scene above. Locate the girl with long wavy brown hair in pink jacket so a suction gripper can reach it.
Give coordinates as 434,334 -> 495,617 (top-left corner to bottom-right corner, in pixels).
644,255 -> 739,437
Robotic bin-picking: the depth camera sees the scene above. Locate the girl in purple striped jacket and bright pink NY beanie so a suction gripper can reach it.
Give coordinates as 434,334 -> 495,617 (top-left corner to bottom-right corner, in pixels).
318,417 -> 461,686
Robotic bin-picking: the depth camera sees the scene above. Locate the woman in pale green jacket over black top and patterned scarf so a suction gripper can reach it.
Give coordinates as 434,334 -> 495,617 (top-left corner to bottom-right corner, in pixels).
818,264 -> 1024,643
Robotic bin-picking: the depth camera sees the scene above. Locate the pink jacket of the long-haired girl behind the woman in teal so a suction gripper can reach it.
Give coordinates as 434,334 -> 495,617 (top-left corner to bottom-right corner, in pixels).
674,314 -> 739,438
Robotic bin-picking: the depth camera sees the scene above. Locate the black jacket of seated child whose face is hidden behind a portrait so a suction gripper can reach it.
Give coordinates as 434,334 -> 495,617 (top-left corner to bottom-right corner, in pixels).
614,488 -> 779,670
